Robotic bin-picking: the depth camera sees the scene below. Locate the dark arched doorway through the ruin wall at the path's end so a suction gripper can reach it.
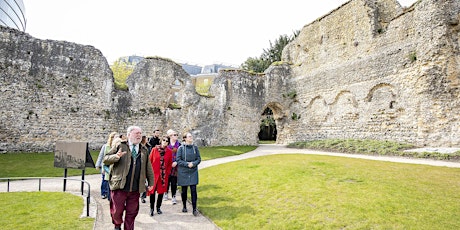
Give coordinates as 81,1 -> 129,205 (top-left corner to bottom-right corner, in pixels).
258,102 -> 283,141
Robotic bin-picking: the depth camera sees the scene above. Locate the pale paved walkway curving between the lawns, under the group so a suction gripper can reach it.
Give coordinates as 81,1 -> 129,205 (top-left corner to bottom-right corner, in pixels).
0,144 -> 460,230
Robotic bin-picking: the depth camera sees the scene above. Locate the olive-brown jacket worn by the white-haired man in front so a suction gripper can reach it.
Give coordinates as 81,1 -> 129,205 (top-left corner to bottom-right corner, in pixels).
103,141 -> 154,193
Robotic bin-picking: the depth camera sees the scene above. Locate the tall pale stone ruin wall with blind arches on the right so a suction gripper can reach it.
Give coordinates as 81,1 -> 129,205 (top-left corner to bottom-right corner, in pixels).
283,0 -> 460,146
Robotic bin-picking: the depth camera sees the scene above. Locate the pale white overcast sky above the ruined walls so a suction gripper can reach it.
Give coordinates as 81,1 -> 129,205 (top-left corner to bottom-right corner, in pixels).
23,0 -> 416,67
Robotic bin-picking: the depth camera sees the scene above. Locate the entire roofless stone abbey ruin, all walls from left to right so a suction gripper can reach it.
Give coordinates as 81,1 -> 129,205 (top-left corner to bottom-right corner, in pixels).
0,0 -> 460,152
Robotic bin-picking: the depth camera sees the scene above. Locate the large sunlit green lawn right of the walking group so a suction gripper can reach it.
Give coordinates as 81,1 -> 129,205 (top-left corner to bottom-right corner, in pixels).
198,155 -> 460,229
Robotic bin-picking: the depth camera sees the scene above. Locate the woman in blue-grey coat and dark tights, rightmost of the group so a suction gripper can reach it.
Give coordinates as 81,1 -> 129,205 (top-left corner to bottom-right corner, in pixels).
176,133 -> 201,216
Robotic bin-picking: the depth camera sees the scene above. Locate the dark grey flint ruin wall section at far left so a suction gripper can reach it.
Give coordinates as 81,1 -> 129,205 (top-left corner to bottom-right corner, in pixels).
0,27 -> 118,152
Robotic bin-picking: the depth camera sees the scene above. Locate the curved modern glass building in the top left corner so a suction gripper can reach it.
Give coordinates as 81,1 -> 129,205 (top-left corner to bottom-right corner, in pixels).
0,0 -> 26,32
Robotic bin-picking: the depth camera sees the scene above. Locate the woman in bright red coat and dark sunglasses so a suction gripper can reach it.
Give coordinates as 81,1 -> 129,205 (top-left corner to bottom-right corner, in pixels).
148,136 -> 172,216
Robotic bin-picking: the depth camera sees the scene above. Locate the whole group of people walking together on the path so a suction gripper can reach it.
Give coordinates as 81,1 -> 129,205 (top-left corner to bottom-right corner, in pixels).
96,126 -> 201,230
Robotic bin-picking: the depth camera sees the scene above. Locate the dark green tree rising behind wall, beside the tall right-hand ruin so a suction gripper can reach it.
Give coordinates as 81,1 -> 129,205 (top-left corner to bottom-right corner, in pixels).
241,31 -> 300,73
